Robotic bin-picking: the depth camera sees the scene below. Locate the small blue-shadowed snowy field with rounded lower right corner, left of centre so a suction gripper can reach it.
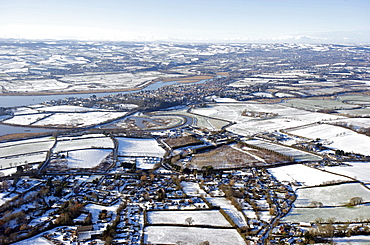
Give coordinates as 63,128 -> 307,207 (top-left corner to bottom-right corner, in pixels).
66,149 -> 112,168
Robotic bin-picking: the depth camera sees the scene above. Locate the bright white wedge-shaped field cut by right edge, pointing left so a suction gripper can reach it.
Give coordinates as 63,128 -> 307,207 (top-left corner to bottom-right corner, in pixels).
325,162 -> 370,183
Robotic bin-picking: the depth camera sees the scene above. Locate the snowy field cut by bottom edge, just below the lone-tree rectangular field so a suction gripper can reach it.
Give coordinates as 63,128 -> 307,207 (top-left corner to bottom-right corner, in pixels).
144,226 -> 245,245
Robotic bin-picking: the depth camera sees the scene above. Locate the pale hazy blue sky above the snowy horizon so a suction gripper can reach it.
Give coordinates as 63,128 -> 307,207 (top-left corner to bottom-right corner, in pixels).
0,0 -> 370,43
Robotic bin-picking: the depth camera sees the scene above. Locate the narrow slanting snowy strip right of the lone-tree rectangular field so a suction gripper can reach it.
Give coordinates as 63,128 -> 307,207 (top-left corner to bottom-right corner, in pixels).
206,197 -> 248,228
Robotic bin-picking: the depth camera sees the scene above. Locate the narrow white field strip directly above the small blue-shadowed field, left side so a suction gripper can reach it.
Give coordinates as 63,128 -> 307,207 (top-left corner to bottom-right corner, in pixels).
53,137 -> 114,152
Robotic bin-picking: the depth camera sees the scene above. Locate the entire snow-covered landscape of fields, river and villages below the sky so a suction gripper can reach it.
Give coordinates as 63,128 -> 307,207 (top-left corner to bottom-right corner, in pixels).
0,39 -> 370,245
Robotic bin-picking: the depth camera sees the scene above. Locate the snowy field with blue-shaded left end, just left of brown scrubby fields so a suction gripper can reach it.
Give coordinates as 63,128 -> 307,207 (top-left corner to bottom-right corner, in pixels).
116,137 -> 166,157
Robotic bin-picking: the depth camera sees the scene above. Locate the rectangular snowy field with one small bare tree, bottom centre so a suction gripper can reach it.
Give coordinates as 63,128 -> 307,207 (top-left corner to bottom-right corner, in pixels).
147,210 -> 232,227
